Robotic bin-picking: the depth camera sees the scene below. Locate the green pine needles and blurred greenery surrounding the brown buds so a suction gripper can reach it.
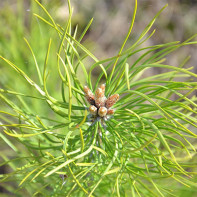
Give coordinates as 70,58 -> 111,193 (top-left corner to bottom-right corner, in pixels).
0,0 -> 197,197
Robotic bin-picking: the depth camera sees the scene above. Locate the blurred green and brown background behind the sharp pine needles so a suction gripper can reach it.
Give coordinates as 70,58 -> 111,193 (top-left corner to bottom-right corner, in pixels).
0,0 -> 197,197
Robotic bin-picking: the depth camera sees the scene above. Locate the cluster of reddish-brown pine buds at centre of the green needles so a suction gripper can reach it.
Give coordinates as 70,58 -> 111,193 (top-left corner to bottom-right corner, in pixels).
84,84 -> 119,118
